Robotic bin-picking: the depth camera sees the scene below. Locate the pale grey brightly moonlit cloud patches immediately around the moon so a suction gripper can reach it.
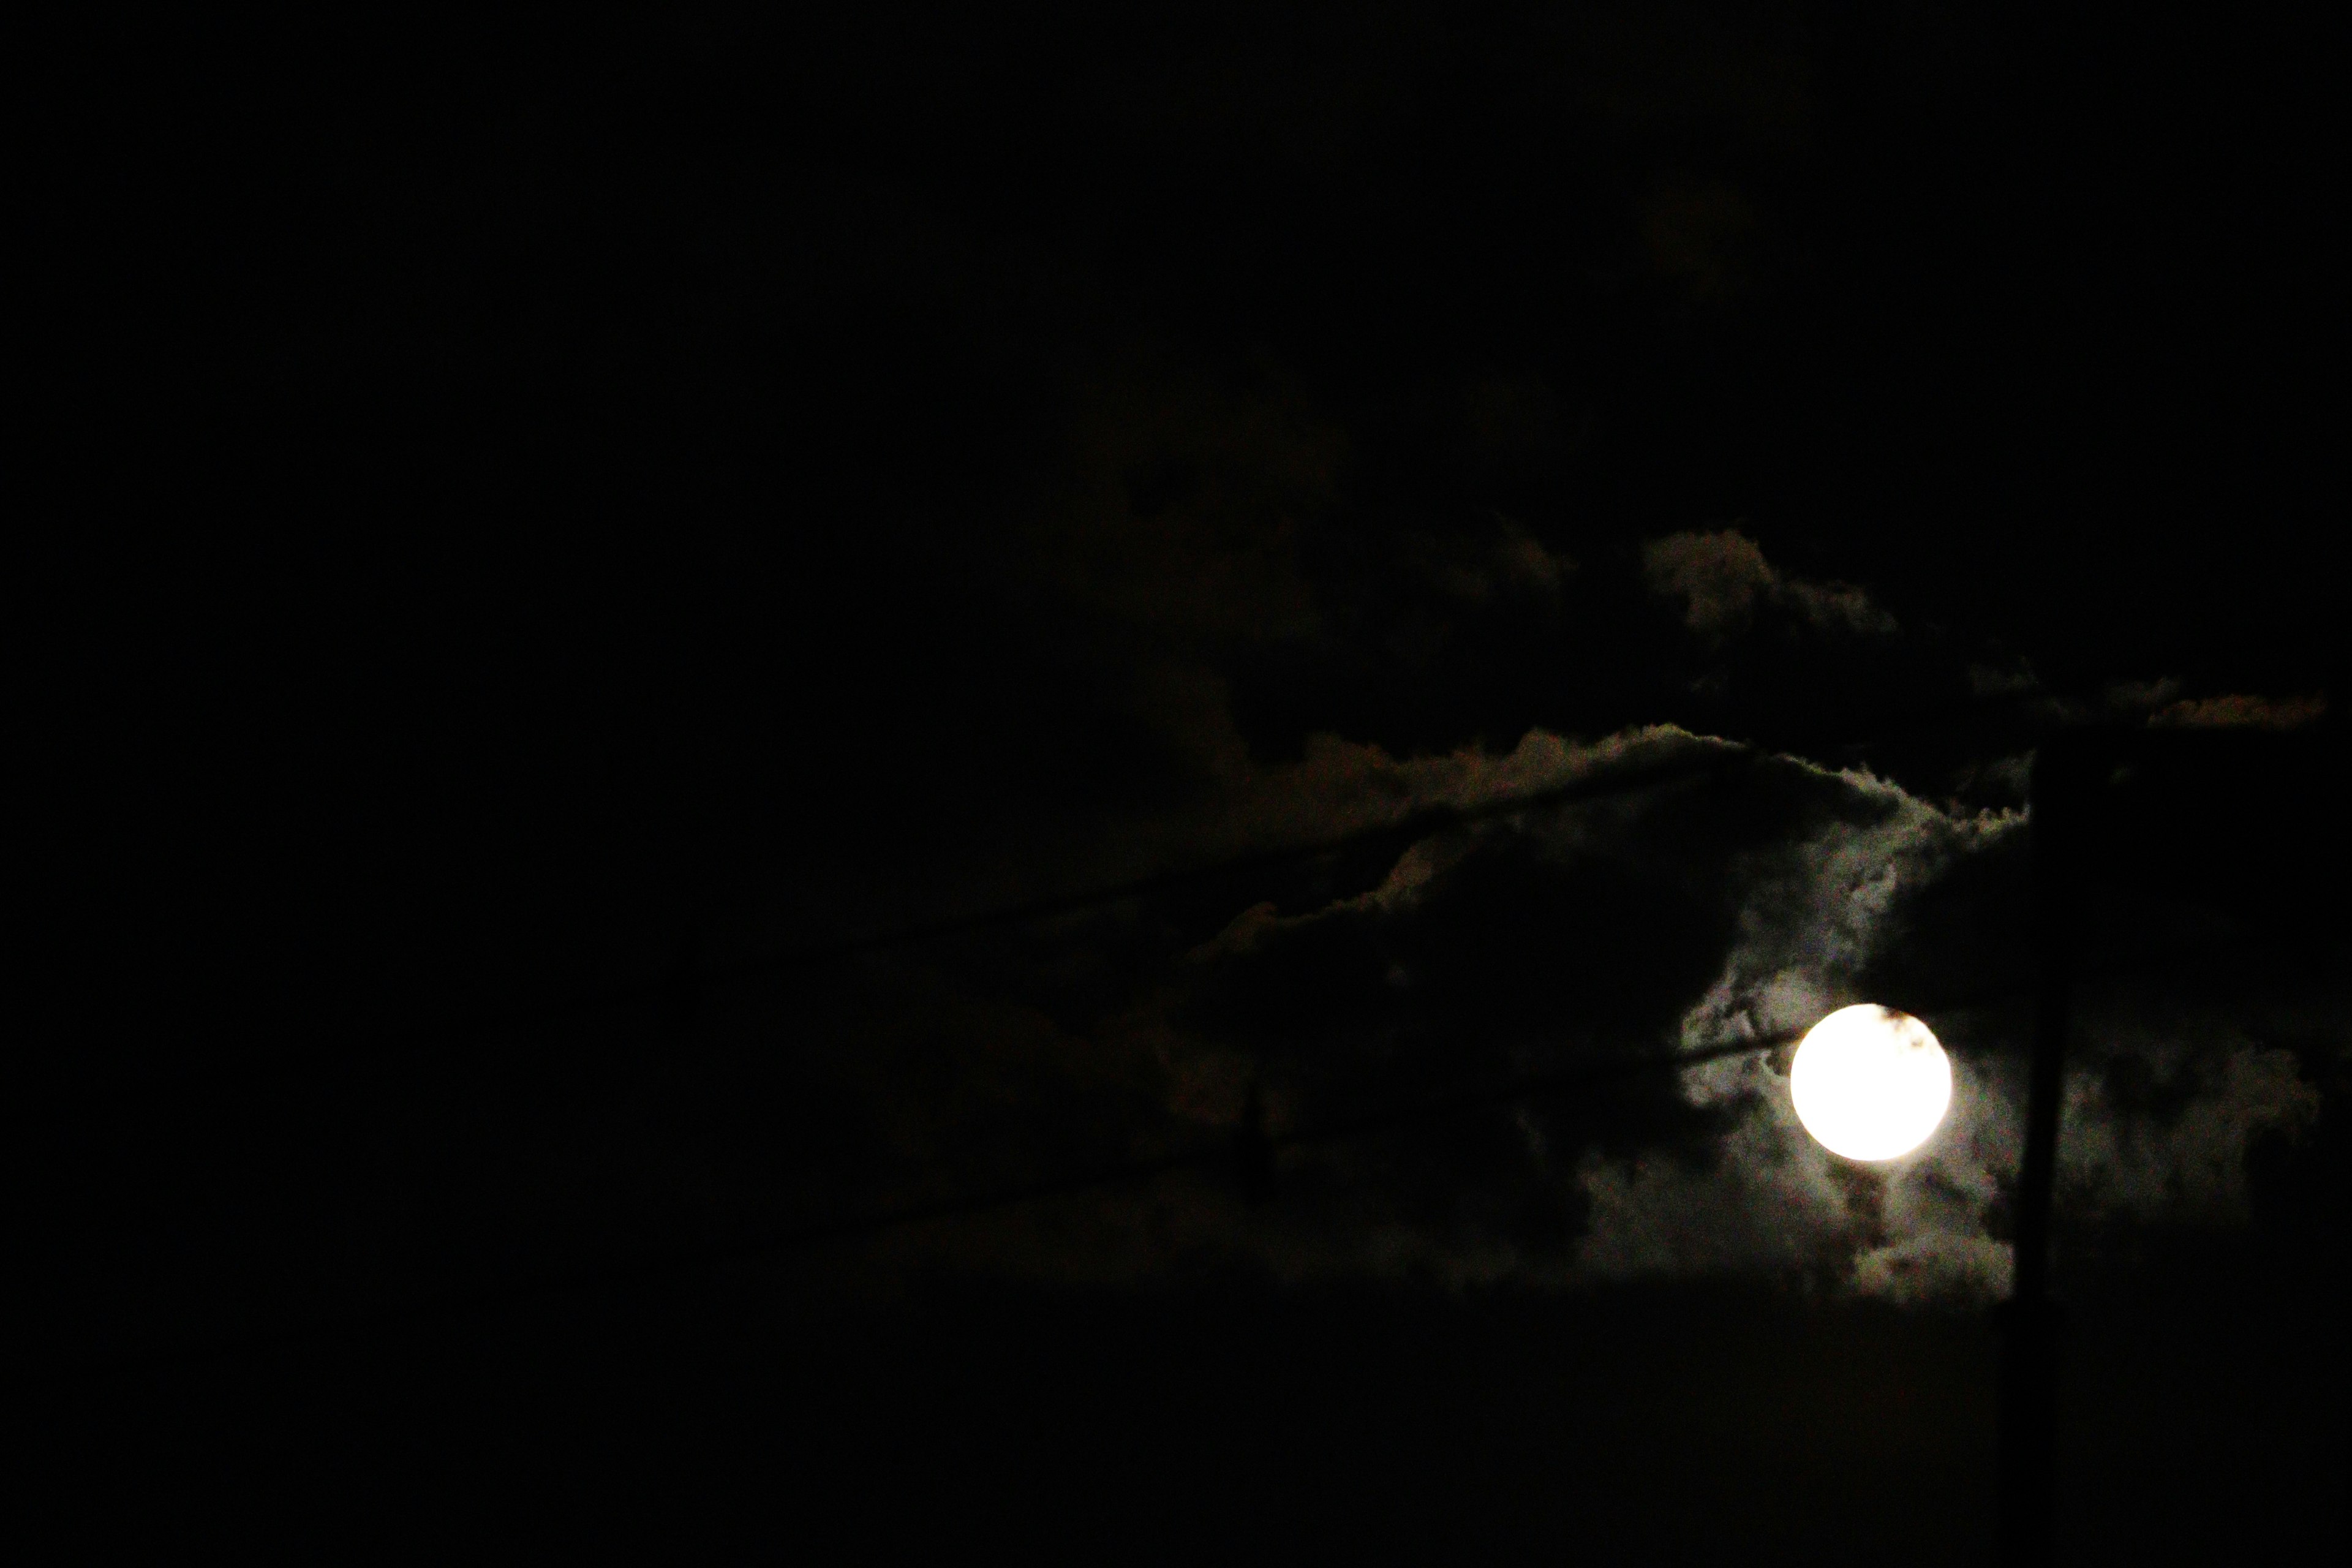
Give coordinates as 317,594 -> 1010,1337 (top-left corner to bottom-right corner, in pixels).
1578,752 -> 2340,1302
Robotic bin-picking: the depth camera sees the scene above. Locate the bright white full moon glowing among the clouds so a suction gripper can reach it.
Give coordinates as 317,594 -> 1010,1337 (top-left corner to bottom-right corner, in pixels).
1787,1001 -> 1952,1159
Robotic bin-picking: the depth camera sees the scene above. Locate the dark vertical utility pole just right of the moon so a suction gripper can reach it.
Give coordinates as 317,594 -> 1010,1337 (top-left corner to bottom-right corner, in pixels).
1999,738 -> 2091,1568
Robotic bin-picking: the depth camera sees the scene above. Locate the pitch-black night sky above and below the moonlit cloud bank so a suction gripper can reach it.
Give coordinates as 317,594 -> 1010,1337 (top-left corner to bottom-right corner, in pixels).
23,5 -> 2343,1561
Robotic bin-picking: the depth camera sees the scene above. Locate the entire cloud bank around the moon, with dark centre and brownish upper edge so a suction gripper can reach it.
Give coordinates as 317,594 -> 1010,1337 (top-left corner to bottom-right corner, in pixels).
729,693 -> 2338,1302
